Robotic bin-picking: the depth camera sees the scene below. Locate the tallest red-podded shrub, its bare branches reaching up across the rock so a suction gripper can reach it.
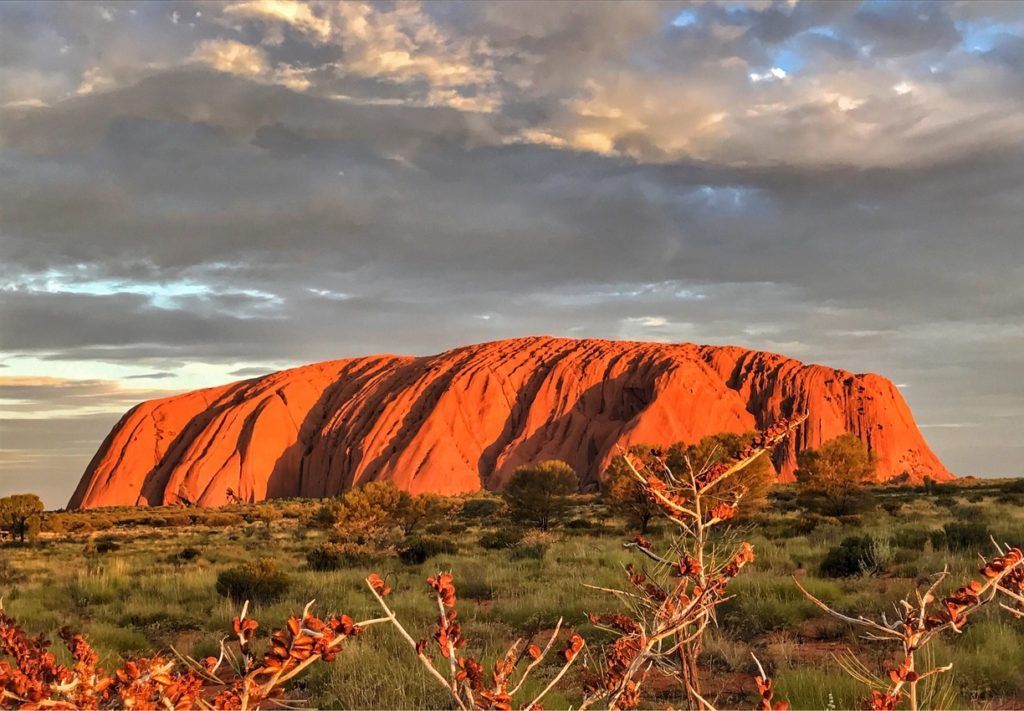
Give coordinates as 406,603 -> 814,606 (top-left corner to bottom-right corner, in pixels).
583,415 -> 806,709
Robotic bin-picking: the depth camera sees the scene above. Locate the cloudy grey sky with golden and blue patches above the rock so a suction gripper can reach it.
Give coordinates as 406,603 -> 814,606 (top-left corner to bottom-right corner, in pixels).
0,0 -> 1024,507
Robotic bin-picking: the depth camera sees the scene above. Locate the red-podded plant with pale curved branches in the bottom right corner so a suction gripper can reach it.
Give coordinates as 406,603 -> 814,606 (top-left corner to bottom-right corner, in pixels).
794,546 -> 1024,710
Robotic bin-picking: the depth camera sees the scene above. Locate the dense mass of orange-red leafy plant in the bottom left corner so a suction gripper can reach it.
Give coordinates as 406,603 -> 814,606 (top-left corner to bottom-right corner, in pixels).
0,602 -> 387,711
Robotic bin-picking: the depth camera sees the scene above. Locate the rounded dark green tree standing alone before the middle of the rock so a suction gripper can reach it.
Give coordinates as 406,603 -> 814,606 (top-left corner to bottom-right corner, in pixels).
502,460 -> 580,531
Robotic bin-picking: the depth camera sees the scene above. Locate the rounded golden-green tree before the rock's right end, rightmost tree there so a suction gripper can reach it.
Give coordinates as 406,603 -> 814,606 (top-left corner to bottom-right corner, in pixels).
796,434 -> 874,515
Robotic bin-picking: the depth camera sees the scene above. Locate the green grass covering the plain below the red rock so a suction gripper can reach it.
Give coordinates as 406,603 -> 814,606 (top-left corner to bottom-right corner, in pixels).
6,488 -> 1024,709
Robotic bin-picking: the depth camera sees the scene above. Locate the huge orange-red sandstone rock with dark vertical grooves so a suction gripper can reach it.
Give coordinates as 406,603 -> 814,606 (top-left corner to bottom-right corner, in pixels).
69,337 -> 952,508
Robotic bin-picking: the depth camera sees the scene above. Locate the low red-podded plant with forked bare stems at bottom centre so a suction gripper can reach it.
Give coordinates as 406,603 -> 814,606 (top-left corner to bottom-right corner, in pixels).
367,573 -> 586,711
